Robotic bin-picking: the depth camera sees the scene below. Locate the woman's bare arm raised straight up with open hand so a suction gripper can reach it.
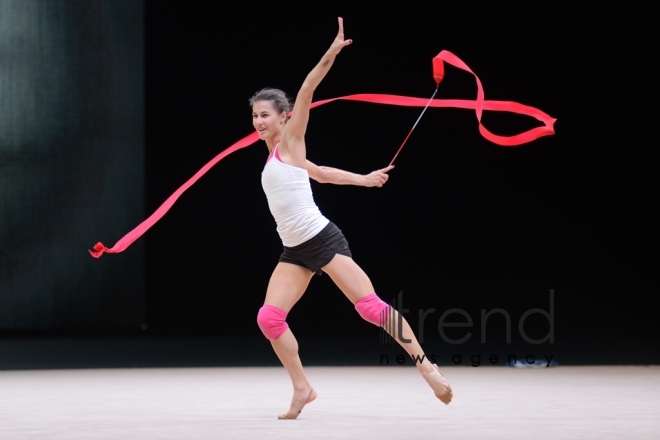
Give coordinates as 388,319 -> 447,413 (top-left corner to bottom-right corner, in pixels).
282,17 -> 353,168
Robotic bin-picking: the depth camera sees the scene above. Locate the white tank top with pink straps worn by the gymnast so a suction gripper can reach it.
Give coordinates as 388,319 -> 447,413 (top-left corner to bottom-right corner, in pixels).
261,144 -> 330,247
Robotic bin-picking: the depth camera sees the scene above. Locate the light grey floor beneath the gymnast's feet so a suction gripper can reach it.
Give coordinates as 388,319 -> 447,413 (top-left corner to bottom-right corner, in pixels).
0,366 -> 660,440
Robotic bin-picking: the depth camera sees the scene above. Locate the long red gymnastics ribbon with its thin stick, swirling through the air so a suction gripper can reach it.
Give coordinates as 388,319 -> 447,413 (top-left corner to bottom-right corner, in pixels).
89,50 -> 556,258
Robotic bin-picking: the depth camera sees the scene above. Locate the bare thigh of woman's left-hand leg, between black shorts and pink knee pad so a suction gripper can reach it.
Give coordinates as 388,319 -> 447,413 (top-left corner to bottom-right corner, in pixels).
264,263 -> 314,313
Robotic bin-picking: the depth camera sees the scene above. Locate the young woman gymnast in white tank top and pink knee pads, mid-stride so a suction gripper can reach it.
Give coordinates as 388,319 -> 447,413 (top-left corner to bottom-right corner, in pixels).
250,18 -> 453,419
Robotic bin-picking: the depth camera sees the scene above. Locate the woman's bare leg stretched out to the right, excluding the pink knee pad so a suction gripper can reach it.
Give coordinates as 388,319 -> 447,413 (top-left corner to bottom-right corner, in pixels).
323,254 -> 453,404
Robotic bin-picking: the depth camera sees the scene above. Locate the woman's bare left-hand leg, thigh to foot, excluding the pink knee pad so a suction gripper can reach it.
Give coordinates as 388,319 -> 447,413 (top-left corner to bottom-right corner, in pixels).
258,263 -> 316,419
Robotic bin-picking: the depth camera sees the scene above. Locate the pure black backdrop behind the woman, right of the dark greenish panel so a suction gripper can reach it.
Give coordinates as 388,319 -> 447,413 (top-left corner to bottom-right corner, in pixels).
2,1 -> 659,364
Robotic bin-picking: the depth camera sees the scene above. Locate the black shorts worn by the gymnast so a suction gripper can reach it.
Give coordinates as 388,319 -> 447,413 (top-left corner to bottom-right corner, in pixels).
280,222 -> 352,275
